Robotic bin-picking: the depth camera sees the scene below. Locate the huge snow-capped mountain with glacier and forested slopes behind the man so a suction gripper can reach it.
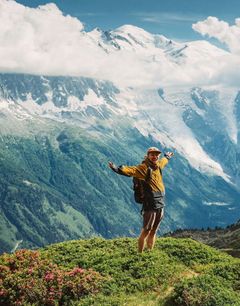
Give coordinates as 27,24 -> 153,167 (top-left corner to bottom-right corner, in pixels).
0,26 -> 240,253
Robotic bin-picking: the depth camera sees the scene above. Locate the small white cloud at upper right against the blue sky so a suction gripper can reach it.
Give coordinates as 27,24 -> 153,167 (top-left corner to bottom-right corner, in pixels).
192,16 -> 240,55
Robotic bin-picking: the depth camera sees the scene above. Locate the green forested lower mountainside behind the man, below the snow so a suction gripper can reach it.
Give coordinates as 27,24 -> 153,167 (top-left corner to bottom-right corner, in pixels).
0,121 -> 239,253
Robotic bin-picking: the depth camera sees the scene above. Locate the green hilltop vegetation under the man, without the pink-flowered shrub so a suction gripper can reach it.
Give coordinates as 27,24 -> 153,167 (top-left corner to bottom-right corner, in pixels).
39,238 -> 240,306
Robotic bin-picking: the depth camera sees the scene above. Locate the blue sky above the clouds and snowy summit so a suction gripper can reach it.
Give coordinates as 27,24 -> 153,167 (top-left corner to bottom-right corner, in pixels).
17,0 -> 240,40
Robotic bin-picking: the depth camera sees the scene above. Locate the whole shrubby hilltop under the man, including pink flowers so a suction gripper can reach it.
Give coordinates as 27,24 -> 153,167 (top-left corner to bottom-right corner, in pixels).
0,238 -> 240,306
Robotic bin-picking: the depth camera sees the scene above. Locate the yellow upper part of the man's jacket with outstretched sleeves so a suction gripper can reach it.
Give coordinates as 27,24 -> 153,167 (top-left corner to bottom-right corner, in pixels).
121,157 -> 168,194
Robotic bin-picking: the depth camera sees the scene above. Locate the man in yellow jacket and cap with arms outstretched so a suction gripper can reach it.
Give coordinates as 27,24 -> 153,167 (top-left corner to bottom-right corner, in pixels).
109,147 -> 173,253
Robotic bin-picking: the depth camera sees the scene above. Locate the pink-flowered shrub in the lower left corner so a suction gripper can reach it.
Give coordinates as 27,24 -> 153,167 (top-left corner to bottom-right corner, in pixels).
0,250 -> 104,306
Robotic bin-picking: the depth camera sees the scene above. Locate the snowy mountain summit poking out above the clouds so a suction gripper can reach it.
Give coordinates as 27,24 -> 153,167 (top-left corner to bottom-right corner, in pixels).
87,25 -> 228,63
